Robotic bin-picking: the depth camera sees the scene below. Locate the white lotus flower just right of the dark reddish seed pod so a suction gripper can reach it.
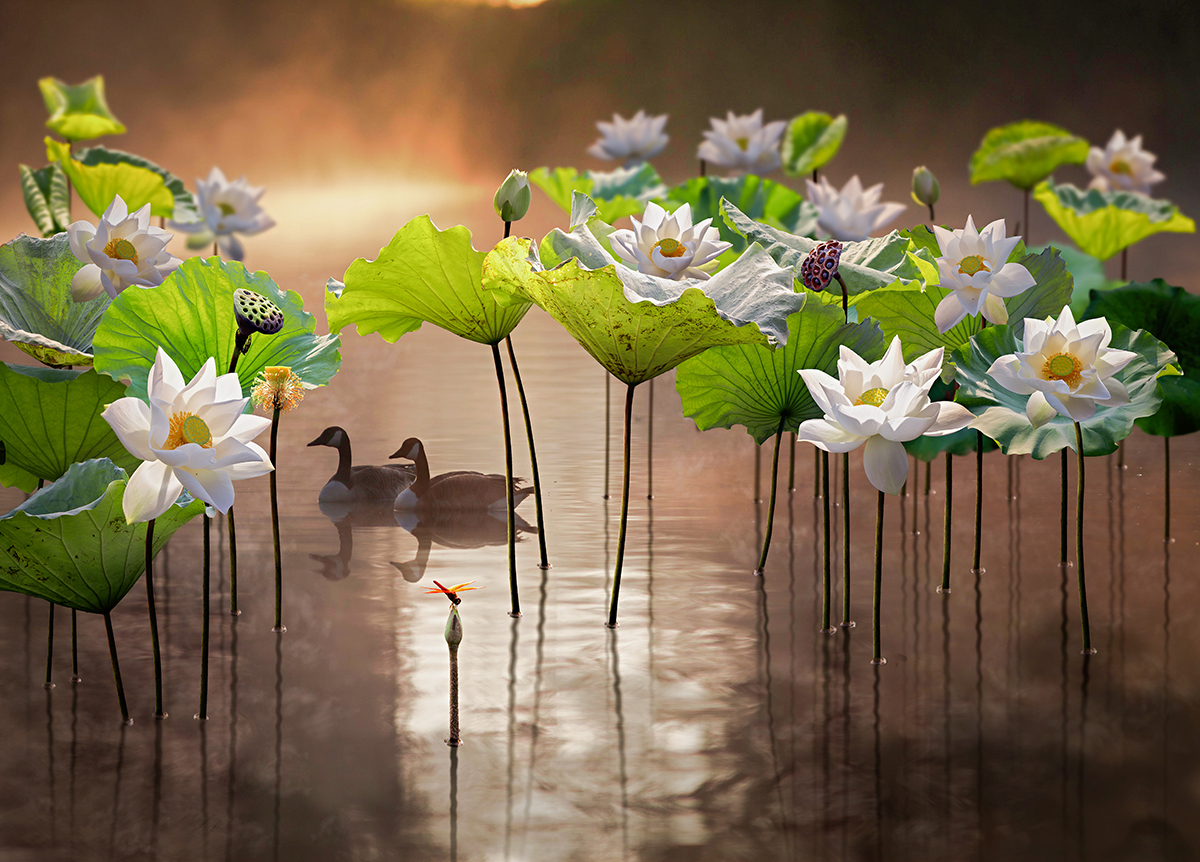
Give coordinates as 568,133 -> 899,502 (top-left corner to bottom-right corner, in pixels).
934,216 -> 1037,333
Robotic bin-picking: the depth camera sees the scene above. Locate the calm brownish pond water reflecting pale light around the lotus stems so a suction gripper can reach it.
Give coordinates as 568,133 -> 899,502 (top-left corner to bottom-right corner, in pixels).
0,311 -> 1200,861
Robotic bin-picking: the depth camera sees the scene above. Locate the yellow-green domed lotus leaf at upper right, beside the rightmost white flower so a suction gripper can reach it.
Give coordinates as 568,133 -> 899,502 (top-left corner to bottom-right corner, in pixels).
971,120 -> 1087,190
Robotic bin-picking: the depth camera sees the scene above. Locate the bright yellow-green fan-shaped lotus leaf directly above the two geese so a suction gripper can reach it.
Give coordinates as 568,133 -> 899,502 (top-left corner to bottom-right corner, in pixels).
325,215 -> 533,345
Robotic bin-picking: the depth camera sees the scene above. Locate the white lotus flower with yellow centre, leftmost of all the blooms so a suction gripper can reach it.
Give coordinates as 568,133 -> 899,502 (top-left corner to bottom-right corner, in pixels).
67,194 -> 180,303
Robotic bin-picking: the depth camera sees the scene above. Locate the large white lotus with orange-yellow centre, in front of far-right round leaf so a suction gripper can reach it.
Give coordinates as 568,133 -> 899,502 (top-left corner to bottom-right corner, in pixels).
988,305 -> 1138,427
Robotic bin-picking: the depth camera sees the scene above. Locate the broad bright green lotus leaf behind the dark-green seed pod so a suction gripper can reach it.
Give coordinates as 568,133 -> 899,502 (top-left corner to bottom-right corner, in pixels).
95,257 -> 342,409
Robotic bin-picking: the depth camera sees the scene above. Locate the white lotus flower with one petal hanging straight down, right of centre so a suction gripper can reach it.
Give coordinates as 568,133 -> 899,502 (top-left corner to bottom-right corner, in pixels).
796,337 -> 974,493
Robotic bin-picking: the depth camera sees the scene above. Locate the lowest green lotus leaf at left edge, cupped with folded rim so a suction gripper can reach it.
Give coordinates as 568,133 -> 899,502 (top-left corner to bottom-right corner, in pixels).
0,459 -> 204,613
